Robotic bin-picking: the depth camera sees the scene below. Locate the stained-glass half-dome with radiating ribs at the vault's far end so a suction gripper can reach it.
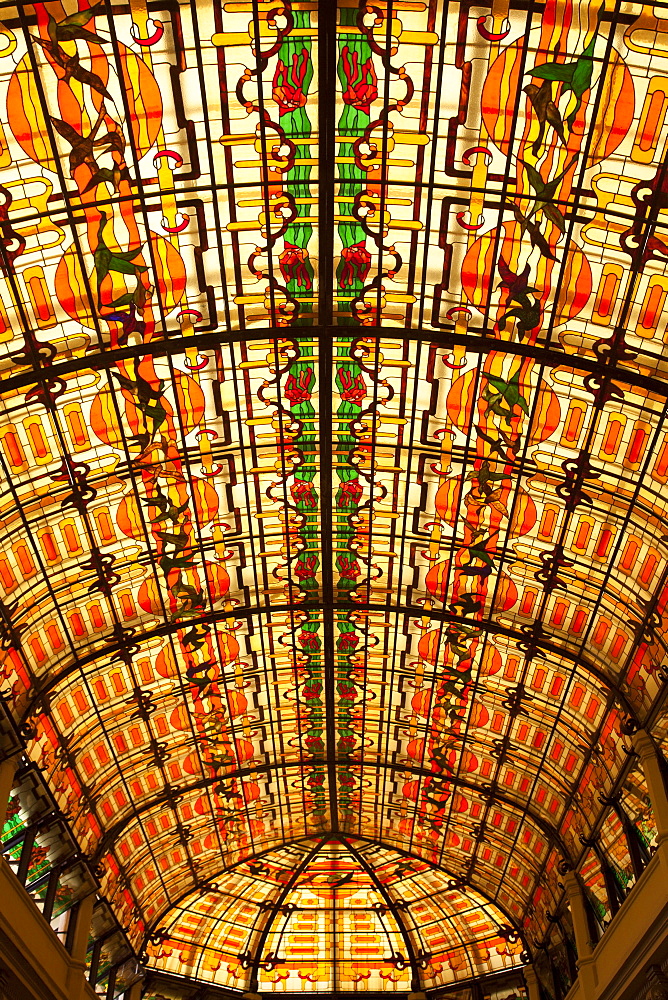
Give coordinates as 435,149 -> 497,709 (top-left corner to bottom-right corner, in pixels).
142,835 -> 523,992
